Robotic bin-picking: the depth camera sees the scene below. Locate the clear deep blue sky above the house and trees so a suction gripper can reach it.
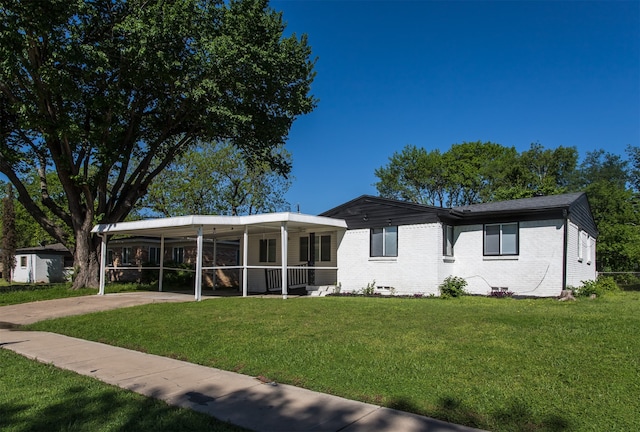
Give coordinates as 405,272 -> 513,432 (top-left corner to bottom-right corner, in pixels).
270,0 -> 640,214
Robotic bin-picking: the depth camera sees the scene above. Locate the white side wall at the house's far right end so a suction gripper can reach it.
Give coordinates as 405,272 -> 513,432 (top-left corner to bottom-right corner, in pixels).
567,222 -> 597,287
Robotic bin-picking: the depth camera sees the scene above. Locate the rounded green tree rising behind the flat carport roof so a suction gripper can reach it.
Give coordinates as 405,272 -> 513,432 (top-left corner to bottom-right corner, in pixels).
138,142 -> 291,217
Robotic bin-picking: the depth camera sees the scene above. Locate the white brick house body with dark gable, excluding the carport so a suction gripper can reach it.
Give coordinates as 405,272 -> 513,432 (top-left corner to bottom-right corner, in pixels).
322,193 -> 598,297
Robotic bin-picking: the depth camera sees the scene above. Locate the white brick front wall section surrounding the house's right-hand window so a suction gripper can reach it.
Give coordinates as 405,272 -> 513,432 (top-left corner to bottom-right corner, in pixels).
450,219 -> 564,297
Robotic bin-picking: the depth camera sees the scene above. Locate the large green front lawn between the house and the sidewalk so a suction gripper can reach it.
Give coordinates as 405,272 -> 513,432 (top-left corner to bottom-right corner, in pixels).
23,292 -> 640,431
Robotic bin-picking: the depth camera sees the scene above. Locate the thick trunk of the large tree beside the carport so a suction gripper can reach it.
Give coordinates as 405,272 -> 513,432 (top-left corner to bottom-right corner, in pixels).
72,228 -> 100,289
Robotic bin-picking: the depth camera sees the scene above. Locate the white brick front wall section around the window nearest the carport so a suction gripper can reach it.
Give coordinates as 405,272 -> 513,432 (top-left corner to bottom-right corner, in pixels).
338,223 -> 442,295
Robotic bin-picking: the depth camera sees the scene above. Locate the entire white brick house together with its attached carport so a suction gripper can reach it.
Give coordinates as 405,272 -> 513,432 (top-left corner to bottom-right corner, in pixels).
93,193 -> 598,300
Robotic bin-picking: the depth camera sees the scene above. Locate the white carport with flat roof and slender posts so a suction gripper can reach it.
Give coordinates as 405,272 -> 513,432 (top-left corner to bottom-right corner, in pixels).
92,212 -> 347,301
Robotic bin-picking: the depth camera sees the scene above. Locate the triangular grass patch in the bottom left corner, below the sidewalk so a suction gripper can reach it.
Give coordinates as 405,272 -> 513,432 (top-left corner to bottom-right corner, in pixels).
0,349 -> 244,432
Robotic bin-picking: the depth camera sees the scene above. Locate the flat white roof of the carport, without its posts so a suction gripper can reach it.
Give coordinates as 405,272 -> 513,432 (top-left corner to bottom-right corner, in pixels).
91,212 -> 347,238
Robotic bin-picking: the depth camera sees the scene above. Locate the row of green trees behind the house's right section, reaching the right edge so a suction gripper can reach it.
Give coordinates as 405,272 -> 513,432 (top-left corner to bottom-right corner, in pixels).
375,142 -> 640,271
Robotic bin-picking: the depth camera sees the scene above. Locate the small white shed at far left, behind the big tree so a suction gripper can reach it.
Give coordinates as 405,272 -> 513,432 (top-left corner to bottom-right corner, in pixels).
13,243 -> 73,283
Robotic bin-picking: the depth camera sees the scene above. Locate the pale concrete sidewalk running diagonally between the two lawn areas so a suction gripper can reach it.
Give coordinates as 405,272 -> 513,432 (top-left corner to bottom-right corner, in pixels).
0,293 -> 476,432
